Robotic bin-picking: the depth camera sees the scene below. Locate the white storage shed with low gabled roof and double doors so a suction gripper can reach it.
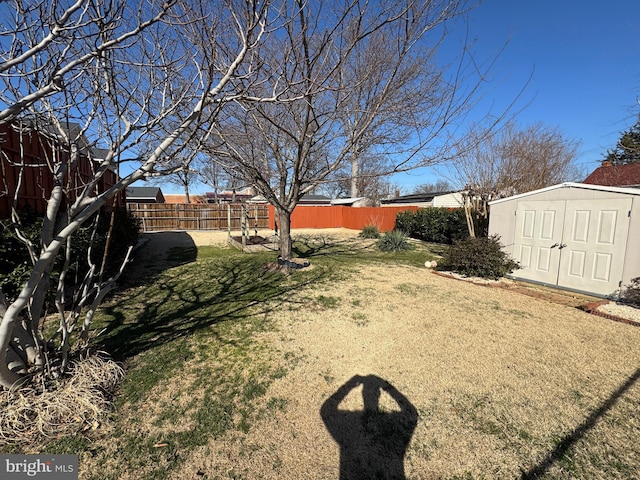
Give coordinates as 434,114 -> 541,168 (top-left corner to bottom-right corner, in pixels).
489,183 -> 640,297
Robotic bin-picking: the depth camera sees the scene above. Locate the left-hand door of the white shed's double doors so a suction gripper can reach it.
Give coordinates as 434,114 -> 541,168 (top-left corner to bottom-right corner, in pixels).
513,201 -> 565,284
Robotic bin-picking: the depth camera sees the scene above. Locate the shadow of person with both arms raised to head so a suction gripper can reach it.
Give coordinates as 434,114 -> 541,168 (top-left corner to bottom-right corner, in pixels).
320,375 -> 418,480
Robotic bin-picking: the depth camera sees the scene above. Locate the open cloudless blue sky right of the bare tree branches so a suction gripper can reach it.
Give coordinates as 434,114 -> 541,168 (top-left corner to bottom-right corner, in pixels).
394,0 -> 640,193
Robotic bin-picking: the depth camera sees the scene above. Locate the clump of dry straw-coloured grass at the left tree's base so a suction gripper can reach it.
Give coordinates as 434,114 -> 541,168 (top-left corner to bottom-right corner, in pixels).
0,355 -> 124,452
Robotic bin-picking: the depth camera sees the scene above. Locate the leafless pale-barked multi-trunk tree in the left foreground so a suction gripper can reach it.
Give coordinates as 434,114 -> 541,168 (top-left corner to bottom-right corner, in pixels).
0,0 -> 272,388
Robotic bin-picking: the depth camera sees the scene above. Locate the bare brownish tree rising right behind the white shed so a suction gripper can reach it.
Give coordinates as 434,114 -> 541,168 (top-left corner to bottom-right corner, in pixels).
449,121 -> 580,236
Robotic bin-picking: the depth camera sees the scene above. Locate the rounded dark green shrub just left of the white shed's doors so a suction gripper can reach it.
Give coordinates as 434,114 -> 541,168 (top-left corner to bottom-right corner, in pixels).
438,235 -> 519,280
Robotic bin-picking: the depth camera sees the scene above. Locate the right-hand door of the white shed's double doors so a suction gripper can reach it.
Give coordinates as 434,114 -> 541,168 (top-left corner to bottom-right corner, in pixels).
558,198 -> 632,295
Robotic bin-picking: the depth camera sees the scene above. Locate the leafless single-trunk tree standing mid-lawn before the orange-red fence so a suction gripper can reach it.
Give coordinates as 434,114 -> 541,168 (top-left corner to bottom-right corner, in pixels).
208,0 -> 502,259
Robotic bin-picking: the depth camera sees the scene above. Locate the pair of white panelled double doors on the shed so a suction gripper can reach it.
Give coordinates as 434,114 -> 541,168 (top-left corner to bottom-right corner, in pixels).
514,198 -> 631,295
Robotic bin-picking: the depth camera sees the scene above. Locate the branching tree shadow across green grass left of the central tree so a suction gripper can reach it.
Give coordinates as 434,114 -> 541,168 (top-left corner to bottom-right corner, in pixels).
100,255 -> 328,360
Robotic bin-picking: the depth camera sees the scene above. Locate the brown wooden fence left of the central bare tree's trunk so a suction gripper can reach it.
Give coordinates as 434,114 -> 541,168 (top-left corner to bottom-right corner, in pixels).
127,203 -> 269,232
